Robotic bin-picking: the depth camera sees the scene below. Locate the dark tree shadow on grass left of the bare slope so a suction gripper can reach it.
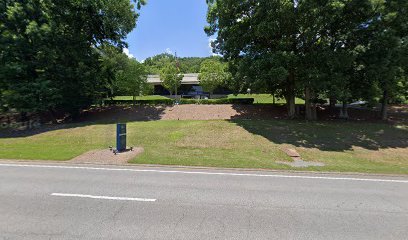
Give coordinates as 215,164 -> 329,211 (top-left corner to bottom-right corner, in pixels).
0,105 -> 166,139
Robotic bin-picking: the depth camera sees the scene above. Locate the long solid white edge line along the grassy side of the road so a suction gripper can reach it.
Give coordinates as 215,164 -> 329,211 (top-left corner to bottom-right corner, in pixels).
0,163 -> 408,183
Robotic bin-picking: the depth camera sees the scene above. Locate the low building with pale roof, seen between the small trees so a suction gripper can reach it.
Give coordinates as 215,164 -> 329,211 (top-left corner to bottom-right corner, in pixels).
147,73 -> 231,96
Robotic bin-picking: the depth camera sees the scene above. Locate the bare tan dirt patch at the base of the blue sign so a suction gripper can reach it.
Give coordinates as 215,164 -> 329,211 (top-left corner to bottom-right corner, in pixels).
69,148 -> 143,164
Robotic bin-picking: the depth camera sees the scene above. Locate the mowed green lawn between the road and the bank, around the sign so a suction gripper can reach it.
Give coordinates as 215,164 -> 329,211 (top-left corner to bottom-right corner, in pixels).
0,120 -> 408,174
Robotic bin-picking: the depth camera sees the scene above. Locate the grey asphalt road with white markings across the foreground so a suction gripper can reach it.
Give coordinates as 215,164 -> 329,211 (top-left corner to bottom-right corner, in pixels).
0,163 -> 408,240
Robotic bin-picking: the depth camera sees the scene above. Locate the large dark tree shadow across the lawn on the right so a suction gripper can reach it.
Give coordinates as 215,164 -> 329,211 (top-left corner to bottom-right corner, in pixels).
231,119 -> 408,152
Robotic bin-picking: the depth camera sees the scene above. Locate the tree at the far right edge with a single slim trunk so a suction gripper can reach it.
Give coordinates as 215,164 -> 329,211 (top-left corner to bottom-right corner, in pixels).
365,0 -> 408,120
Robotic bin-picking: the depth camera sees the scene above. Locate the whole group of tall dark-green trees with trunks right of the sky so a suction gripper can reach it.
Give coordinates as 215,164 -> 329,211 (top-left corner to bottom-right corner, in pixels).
205,0 -> 408,120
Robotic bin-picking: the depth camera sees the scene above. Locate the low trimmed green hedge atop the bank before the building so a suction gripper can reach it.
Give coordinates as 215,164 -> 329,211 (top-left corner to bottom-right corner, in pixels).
104,98 -> 254,105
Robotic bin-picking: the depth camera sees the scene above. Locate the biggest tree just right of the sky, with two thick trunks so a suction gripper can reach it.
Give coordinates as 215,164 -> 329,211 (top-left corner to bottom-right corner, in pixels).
205,0 -> 381,119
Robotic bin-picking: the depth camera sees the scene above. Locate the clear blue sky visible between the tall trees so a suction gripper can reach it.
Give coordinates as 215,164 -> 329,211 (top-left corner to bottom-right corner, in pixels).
124,0 -> 213,61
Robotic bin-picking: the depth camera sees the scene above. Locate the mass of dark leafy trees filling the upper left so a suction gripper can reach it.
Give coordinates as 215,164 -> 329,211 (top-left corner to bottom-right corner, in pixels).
0,0 -> 145,118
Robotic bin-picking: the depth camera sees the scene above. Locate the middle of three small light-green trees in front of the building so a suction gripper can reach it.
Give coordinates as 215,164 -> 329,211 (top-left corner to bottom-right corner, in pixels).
160,62 -> 184,96
